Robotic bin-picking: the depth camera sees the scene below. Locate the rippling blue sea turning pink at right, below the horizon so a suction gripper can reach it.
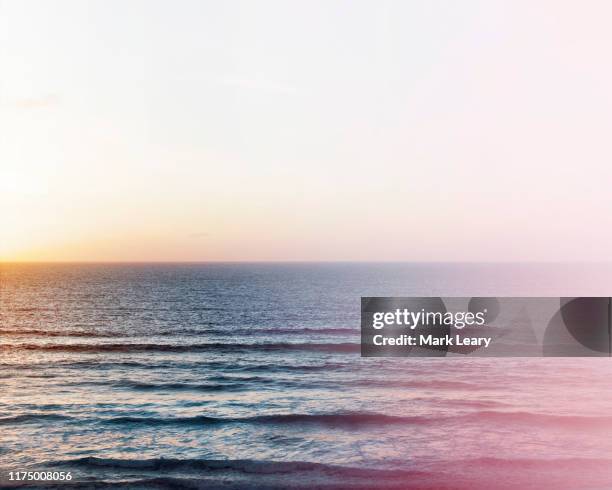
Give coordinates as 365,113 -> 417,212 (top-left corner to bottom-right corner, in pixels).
0,264 -> 612,489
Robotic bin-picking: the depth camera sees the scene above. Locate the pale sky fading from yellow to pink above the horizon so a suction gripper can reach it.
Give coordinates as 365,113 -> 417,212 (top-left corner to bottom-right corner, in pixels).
0,0 -> 612,261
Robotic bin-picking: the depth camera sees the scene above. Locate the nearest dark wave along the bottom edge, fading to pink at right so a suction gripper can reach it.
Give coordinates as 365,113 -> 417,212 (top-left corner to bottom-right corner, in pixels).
32,457 -> 612,490
